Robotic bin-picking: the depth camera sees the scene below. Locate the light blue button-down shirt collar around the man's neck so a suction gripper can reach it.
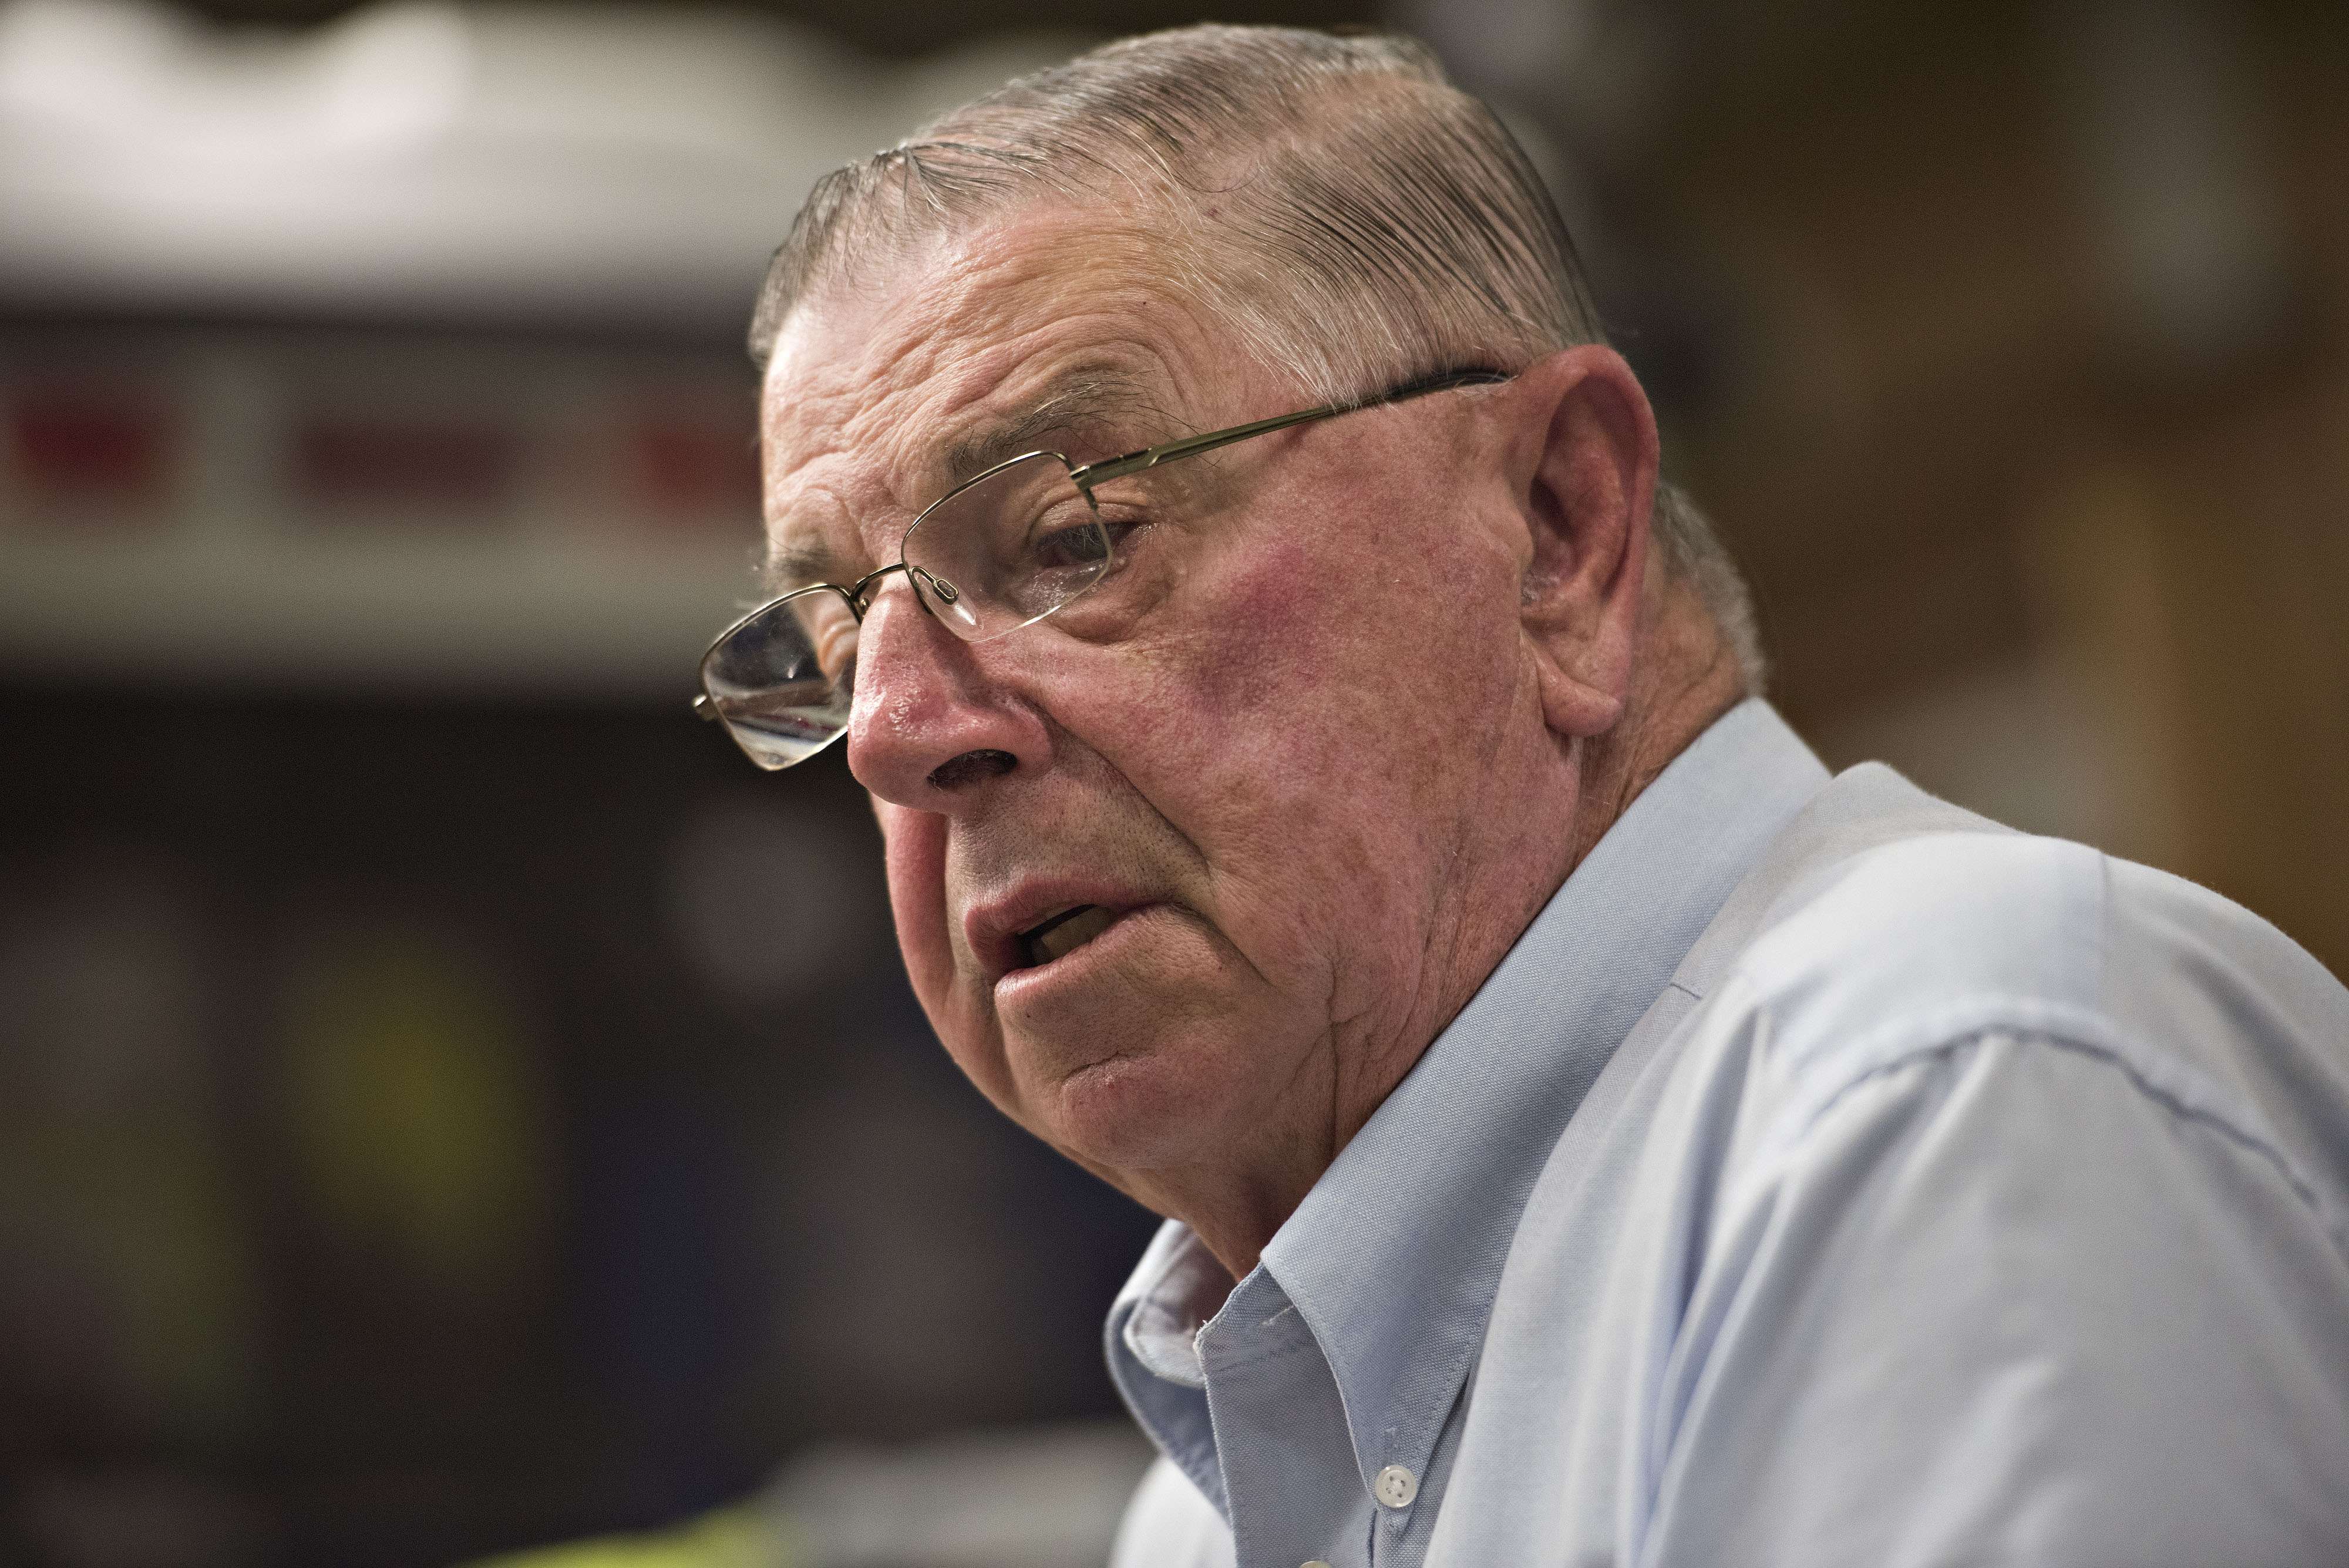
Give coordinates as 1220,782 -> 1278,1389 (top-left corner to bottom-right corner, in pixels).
1109,699 -> 1830,1483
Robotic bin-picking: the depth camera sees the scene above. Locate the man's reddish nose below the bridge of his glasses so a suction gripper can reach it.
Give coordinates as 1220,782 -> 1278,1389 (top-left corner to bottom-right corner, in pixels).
848,577 -> 1045,815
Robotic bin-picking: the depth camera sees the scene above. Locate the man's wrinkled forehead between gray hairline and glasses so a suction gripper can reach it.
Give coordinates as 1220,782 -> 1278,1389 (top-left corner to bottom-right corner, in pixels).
759,209 -> 1247,582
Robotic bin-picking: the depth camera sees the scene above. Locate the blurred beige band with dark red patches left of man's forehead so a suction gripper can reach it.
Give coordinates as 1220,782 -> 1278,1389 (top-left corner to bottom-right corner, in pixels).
0,327 -> 759,695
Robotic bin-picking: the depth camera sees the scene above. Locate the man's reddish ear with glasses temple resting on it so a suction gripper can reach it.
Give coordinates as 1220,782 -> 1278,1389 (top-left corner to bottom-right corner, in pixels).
1506,343 -> 1656,737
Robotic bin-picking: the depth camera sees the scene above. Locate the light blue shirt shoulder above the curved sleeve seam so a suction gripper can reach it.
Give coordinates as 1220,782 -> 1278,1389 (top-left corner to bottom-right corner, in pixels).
1691,831 -> 2349,1223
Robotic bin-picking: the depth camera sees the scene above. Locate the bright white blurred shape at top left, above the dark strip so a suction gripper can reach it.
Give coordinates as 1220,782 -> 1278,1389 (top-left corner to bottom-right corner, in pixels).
0,0 -> 1081,329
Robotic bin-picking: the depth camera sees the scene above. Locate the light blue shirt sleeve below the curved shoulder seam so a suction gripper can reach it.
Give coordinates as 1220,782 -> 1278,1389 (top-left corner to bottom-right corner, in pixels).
1640,1035 -> 2349,1568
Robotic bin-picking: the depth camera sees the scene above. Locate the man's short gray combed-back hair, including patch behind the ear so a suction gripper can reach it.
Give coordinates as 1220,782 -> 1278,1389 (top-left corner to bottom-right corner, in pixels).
749,26 -> 1764,692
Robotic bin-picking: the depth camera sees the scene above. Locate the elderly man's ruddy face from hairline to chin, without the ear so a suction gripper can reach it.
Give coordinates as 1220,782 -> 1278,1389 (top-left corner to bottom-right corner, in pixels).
763,209 -> 1557,1206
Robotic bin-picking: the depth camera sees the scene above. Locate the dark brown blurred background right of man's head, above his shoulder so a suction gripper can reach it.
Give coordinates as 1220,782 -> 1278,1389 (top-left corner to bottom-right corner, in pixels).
1409,0 -> 2349,970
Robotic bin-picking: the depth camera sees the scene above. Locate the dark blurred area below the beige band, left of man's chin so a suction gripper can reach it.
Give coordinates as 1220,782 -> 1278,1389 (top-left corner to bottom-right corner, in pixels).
0,685 -> 1165,1563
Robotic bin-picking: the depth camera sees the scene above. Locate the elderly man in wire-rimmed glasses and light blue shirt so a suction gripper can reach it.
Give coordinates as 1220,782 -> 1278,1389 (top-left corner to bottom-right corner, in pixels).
702,28 -> 2349,1568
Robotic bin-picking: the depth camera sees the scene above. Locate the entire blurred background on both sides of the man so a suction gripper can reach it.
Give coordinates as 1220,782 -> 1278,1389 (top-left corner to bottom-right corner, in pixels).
0,0 -> 2349,1568
